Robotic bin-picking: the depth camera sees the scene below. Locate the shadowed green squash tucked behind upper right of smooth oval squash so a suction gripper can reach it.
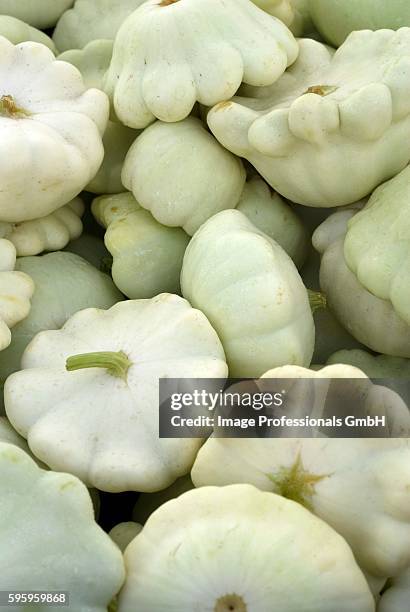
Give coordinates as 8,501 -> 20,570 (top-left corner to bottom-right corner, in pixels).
236,177 -> 310,268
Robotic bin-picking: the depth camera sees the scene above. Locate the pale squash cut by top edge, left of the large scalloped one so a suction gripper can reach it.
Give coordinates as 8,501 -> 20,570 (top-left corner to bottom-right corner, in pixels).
53,0 -> 144,51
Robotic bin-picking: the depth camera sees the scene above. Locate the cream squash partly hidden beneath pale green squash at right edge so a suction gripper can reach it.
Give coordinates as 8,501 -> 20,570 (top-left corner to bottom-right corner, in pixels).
312,209 -> 410,358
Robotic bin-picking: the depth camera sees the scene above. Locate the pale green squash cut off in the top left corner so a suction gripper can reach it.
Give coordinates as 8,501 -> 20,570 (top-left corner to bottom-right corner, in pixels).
0,0 -> 74,28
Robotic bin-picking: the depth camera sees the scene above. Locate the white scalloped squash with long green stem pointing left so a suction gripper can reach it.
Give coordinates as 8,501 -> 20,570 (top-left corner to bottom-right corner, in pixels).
4,294 -> 227,492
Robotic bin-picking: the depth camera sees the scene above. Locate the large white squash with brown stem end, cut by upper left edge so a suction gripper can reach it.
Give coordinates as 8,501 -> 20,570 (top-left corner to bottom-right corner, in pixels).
0,37 -> 109,222
